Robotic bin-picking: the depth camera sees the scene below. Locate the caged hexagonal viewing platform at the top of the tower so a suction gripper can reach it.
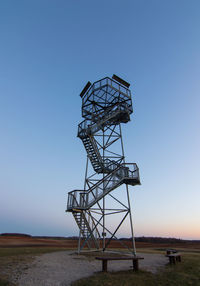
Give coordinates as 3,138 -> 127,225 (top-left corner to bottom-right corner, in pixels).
82,77 -> 133,124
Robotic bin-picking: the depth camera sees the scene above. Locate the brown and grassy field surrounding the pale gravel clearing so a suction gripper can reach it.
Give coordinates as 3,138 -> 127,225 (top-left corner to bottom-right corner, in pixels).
0,236 -> 200,286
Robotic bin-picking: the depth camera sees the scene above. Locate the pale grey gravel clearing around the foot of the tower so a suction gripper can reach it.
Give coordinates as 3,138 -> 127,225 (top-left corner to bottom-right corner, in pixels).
12,251 -> 167,286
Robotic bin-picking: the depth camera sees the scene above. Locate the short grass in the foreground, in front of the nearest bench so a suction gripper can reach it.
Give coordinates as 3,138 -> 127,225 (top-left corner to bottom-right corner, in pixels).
72,254 -> 200,286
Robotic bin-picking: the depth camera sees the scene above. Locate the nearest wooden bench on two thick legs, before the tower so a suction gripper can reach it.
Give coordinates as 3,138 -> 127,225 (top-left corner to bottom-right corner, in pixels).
96,256 -> 144,272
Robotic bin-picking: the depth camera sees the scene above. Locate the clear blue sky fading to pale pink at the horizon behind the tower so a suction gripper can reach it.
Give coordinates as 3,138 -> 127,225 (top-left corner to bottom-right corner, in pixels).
0,0 -> 200,239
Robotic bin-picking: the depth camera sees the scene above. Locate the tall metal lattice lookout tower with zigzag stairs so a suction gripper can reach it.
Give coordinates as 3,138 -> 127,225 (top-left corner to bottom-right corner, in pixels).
66,75 -> 140,255
